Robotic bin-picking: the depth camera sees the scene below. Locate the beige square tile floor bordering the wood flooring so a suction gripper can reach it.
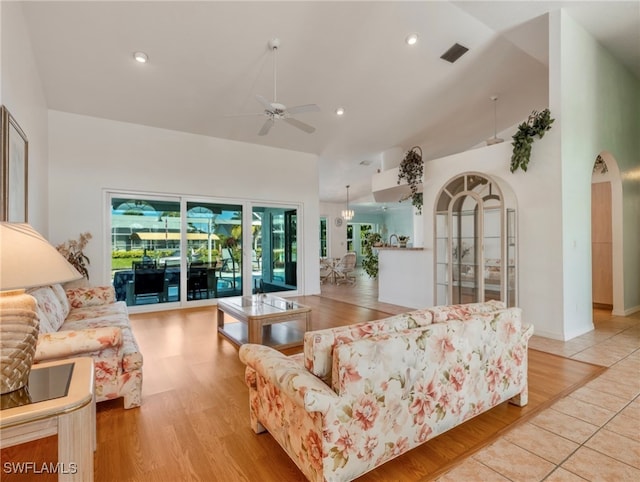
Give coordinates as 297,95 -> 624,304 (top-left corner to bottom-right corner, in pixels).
322,272 -> 640,482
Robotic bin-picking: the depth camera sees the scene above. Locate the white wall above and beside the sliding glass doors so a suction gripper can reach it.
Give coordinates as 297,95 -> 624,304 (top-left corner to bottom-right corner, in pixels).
49,111 -> 320,294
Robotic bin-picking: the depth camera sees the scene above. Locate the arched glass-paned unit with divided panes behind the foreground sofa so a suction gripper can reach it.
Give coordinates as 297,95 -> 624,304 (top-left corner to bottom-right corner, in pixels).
434,172 -> 517,306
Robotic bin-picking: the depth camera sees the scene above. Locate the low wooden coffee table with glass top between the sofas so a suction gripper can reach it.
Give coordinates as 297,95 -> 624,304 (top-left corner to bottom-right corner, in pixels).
218,294 -> 311,348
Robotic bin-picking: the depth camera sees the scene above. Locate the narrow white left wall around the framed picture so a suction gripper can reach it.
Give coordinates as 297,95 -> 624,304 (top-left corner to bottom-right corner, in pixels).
0,2 -> 49,232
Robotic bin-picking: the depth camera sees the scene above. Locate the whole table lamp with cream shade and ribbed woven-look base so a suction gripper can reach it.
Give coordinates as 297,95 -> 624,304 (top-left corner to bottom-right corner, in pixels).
0,222 -> 82,394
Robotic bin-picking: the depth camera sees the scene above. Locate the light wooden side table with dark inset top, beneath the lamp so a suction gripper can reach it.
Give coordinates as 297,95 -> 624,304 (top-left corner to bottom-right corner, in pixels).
0,357 -> 96,482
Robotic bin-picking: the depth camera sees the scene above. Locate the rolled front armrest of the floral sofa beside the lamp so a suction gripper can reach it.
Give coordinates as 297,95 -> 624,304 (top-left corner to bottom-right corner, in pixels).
34,326 -> 122,361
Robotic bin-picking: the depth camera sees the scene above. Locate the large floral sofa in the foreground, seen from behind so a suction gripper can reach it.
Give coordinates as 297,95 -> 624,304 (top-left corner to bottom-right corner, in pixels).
240,301 -> 533,481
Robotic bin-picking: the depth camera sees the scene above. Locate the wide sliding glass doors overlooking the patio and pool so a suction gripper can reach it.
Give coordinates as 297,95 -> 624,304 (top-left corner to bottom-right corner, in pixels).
109,193 -> 299,306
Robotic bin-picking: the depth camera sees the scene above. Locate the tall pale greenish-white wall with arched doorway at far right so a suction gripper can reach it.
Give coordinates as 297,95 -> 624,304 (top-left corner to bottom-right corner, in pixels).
550,11 -> 640,324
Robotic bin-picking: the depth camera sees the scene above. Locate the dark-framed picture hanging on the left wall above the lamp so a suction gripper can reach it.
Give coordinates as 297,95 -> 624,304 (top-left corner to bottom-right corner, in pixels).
0,106 -> 29,223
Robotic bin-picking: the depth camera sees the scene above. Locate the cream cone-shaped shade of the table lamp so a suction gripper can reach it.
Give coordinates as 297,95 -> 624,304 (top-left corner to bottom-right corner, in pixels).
0,222 -> 82,291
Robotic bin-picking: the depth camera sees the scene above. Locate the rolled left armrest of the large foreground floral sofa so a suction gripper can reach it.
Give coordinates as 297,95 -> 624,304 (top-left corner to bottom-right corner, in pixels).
240,343 -> 338,414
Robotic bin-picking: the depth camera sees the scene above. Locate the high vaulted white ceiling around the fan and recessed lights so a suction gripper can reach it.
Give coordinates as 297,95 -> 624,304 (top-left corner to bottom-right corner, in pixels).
23,1 -> 640,209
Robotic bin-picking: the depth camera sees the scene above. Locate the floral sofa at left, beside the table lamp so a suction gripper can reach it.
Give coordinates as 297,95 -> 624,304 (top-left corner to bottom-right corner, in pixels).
29,284 -> 142,408
